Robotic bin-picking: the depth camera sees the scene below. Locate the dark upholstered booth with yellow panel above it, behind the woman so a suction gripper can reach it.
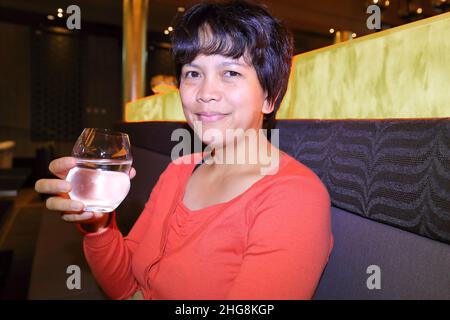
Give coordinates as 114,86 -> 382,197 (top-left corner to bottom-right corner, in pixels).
29,13 -> 450,299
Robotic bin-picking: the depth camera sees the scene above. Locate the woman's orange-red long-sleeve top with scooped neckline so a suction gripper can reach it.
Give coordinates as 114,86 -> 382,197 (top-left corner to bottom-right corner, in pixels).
83,153 -> 333,300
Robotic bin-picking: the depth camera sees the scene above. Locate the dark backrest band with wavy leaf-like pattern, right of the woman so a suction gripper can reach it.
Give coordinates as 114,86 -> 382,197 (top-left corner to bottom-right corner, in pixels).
277,119 -> 450,243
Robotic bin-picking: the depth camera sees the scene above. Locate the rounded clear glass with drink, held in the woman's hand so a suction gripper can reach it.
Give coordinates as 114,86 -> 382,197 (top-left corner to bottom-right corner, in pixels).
66,128 -> 132,212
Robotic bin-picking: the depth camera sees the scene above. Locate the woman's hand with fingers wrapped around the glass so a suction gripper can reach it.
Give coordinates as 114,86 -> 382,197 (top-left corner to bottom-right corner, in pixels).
35,157 -> 136,231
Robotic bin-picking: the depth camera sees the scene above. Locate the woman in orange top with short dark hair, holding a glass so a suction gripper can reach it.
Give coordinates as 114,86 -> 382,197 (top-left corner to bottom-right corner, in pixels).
36,1 -> 333,299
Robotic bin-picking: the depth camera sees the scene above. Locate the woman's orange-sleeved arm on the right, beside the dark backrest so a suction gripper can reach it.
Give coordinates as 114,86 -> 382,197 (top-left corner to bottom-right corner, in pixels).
227,177 -> 332,300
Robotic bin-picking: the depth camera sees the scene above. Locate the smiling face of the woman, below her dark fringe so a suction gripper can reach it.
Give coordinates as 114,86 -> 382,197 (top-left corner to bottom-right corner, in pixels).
180,55 -> 273,146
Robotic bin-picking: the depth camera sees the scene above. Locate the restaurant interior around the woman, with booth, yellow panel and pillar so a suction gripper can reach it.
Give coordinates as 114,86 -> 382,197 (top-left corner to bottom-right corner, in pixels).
0,0 -> 450,300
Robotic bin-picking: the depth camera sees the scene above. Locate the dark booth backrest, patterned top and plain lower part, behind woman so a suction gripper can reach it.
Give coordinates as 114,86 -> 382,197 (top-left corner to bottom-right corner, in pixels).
117,119 -> 450,299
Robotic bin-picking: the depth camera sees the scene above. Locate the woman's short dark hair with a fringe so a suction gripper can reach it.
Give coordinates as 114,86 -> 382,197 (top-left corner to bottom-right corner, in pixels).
172,0 -> 293,118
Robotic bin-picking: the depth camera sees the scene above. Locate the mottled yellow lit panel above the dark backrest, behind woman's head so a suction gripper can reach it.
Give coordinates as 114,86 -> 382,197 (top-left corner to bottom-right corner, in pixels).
126,13 -> 450,121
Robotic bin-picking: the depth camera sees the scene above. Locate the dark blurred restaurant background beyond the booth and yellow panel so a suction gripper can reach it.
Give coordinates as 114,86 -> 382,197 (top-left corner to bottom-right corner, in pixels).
0,0 -> 449,299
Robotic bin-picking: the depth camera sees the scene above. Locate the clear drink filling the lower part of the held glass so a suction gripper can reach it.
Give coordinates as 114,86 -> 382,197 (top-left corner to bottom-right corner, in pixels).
66,158 -> 132,212
